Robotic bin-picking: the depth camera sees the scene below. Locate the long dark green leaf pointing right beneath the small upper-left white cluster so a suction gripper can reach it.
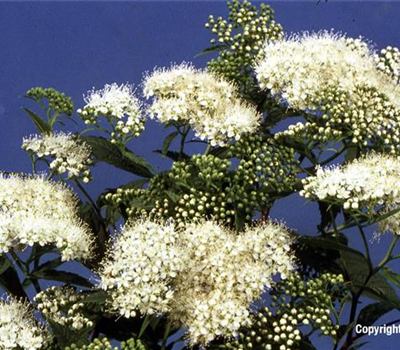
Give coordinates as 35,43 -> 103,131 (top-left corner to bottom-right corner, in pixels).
81,136 -> 155,178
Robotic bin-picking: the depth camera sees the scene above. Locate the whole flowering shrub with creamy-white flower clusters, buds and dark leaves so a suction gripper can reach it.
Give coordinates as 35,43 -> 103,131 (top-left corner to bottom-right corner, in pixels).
0,0 -> 400,350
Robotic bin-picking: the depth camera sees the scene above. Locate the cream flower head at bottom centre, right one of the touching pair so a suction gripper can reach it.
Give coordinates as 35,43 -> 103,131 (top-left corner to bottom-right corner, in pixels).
170,221 -> 293,344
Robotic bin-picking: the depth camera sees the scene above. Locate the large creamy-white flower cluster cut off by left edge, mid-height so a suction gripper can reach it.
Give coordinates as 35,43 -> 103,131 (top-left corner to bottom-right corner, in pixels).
0,174 -> 92,260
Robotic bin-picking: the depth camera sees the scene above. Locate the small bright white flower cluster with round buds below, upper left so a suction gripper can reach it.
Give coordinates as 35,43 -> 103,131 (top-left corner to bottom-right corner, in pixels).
77,83 -> 145,141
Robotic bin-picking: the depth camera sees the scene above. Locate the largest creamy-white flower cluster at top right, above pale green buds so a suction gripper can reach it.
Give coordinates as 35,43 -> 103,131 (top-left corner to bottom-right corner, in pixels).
255,32 -> 400,109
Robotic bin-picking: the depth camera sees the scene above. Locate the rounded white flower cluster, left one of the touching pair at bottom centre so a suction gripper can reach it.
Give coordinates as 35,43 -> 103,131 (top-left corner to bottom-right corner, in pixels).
100,221 -> 183,317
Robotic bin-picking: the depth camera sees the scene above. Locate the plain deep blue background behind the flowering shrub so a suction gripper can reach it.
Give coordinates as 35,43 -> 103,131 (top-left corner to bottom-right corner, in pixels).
0,0 -> 400,350
